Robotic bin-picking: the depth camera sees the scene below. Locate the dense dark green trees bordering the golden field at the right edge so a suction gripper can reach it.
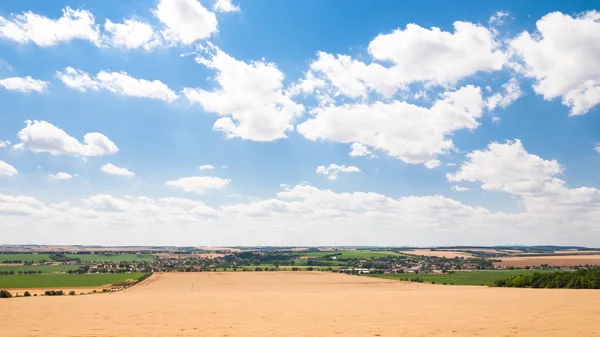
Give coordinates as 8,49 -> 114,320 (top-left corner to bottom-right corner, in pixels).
494,268 -> 600,289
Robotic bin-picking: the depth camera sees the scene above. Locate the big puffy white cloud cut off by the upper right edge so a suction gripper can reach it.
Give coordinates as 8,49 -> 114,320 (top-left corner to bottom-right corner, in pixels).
510,11 -> 600,115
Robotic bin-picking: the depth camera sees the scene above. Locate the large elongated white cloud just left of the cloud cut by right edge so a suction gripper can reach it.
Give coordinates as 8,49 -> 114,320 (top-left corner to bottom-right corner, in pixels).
298,22 -> 507,98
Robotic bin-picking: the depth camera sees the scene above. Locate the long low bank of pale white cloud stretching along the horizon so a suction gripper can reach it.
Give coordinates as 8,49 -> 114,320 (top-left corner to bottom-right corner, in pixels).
0,178 -> 599,246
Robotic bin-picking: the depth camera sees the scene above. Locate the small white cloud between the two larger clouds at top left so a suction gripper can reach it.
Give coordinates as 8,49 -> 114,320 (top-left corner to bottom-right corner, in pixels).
104,19 -> 162,50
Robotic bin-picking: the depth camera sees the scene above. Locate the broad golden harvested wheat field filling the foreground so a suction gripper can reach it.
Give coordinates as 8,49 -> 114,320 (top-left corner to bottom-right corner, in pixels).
0,272 -> 600,337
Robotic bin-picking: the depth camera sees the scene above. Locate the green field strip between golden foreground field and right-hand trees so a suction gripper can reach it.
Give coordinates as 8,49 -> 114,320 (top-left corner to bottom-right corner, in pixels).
367,269 -> 552,286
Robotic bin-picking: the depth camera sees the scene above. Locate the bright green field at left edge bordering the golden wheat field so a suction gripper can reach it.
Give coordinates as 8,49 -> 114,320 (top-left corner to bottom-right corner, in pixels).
0,273 -> 144,289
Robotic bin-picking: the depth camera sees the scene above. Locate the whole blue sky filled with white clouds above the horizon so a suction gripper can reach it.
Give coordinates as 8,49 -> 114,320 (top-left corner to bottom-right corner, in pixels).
0,0 -> 600,246
